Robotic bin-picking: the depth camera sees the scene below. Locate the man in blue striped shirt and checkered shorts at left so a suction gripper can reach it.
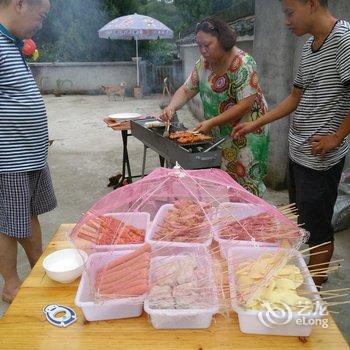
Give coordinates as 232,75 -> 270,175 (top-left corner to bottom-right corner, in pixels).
0,0 -> 56,302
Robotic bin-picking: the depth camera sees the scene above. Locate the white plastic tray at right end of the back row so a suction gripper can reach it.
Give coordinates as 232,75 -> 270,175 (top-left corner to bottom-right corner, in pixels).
213,202 -> 276,259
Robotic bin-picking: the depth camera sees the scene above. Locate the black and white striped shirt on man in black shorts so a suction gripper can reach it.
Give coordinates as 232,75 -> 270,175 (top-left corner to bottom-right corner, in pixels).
289,20 -> 350,170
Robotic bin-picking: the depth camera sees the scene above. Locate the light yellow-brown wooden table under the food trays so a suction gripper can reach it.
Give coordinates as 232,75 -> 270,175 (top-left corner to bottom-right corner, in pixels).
0,224 -> 349,350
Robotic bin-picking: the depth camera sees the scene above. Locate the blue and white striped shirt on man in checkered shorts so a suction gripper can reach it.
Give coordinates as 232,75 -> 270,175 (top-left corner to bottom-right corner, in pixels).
0,25 -> 48,173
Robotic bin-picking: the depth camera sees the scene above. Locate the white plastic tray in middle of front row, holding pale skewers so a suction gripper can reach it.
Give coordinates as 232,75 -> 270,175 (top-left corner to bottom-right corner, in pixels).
144,254 -> 219,329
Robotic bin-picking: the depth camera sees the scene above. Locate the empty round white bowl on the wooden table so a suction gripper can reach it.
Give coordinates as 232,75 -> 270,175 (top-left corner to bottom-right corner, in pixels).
43,248 -> 87,283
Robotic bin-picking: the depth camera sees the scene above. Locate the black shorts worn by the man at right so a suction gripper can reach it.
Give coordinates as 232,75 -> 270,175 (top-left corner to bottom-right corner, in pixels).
289,158 -> 345,246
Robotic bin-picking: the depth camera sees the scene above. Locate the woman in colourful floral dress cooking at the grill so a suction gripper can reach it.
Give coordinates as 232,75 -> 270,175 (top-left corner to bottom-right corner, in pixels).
163,18 -> 269,197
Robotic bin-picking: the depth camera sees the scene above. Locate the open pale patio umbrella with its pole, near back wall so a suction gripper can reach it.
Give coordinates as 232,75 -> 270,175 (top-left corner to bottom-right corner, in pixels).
98,13 -> 174,86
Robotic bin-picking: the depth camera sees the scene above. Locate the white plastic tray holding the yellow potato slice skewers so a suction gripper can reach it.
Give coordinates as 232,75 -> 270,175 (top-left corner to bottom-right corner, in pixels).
228,246 -> 322,337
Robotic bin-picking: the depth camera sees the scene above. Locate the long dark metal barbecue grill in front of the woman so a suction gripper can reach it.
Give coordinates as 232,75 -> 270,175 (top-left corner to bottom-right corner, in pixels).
131,118 -> 222,175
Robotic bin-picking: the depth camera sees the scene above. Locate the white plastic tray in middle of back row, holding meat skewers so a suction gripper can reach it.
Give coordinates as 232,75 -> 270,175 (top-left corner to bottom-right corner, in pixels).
146,204 -> 213,248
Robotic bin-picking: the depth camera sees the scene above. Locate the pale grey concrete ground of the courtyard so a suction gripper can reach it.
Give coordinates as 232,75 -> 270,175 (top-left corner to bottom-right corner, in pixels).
0,95 -> 350,342
